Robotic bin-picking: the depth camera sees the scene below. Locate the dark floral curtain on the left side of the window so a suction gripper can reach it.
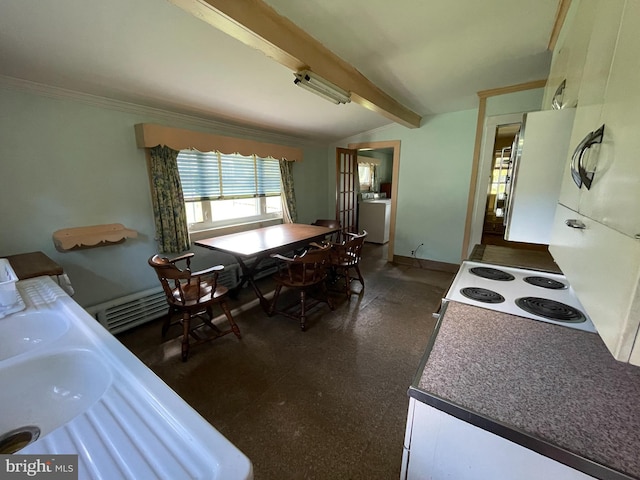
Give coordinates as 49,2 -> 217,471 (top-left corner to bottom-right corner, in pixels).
149,145 -> 191,253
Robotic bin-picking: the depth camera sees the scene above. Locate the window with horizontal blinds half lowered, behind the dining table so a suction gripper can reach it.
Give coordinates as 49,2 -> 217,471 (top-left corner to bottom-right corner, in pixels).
178,150 -> 282,232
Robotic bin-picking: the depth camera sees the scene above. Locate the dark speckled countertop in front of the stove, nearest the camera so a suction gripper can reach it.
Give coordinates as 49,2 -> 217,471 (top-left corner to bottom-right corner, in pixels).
409,302 -> 640,479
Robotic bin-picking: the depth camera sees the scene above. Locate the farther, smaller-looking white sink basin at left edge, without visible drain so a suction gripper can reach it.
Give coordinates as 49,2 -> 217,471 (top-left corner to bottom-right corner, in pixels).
0,310 -> 69,361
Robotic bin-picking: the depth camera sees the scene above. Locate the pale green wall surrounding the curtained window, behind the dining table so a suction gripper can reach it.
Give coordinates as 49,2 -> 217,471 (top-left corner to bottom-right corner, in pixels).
0,87 -> 328,307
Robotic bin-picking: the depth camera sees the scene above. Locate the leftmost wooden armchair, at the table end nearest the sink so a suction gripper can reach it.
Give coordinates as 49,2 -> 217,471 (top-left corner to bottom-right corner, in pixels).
149,253 -> 241,362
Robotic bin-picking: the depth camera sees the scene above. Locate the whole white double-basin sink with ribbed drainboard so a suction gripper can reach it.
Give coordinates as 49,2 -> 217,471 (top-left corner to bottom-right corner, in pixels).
6,277 -> 253,480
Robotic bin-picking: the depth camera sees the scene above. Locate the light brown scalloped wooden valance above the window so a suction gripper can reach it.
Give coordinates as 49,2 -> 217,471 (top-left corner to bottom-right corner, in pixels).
135,123 -> 302,161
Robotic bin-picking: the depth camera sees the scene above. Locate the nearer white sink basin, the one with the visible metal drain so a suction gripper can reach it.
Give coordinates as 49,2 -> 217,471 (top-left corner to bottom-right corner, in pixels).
0,350 -> 112,444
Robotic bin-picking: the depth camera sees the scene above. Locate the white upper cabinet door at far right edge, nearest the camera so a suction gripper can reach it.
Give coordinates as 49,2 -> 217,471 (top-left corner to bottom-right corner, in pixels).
579,0 -> 640,237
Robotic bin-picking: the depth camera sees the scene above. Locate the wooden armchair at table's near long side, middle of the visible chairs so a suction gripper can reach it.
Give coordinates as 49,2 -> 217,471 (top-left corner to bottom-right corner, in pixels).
269,246 -> 333,332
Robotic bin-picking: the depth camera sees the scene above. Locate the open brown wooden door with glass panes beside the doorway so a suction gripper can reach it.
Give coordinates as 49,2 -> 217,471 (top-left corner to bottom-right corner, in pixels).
336,148 -> 358,232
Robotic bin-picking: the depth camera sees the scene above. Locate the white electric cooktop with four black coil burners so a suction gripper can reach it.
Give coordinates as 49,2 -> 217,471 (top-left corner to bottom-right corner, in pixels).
445,261 -> 597,332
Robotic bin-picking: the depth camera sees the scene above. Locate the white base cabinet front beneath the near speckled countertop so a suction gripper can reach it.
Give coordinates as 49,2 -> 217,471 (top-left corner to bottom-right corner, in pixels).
401,398 -> 593,480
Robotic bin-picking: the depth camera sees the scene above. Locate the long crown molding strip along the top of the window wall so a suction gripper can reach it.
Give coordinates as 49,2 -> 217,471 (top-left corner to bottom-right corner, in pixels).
0,75 -> 329,147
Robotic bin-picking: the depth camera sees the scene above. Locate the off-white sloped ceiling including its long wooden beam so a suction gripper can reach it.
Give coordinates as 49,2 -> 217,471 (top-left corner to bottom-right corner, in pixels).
0,0 -> 566,141
